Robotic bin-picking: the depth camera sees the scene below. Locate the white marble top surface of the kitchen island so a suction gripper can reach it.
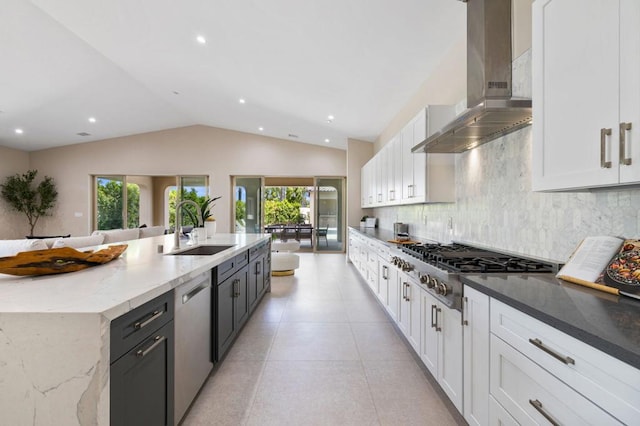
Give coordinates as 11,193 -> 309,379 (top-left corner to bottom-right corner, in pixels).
0,234 -> 269,320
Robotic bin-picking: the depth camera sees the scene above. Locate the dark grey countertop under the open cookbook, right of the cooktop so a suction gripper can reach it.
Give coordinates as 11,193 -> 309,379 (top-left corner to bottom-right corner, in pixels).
461,274 -> 640,368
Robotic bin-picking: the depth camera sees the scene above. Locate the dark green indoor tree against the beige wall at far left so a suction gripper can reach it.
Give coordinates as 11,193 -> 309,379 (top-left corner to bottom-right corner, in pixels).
0,170 -> 58,237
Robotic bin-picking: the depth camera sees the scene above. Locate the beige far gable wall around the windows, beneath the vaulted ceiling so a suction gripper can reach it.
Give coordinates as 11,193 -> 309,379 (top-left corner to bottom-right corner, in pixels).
26,126 -> 347,238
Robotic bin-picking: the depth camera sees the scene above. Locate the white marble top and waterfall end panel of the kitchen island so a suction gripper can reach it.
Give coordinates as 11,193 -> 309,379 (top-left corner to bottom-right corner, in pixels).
0,234 -> 269,425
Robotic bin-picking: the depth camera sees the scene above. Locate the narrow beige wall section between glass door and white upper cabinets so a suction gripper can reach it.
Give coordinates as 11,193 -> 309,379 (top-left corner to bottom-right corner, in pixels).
347,139 -> 373,226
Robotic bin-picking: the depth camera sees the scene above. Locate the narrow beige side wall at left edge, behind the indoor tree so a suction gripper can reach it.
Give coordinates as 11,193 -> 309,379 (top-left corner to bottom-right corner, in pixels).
0,146 -> 31,239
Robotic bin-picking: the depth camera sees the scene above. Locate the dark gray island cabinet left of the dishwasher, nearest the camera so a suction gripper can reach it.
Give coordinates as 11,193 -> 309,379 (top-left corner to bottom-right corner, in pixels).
110,291 -> 174,426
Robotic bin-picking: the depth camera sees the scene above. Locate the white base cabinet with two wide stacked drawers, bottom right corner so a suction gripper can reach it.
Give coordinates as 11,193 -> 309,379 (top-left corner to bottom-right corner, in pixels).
490,299 -> 640,425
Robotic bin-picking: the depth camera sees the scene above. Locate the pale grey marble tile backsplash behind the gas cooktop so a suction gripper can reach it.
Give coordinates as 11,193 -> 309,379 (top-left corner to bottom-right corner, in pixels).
373,52 -> 640,261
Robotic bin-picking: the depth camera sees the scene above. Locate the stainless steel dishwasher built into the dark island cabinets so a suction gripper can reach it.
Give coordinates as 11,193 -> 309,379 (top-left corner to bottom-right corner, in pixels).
174,272 -> 213,425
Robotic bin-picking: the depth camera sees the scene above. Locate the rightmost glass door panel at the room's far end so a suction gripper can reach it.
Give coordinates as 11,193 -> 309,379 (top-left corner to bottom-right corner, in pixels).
314,177 -> 345,252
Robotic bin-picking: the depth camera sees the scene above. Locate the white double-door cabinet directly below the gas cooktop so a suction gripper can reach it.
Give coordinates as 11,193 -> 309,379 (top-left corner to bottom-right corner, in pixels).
420,291 -> 463,412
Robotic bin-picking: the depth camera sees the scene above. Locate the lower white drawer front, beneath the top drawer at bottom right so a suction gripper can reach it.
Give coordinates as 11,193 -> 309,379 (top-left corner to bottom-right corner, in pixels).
490,334 -> 621,425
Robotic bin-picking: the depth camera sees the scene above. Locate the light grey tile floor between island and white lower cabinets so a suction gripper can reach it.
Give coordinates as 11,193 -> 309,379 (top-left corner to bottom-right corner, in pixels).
182,253 -> 466,426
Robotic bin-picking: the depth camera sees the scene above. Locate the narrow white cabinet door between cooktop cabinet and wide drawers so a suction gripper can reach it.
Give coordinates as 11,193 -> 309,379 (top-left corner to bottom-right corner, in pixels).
462,286 -> 489,426
